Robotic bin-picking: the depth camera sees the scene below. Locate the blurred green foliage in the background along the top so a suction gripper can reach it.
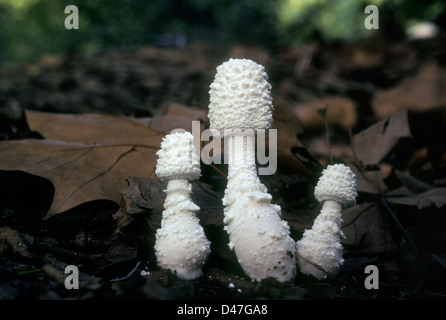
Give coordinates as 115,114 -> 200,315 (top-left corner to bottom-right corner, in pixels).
0,0 -> 446,63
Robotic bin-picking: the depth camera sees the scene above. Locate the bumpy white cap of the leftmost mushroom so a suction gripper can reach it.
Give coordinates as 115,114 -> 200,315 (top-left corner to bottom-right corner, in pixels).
155,132 -> 201,181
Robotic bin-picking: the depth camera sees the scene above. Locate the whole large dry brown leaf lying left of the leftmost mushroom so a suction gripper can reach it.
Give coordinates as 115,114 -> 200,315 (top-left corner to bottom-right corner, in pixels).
0,112 -> 164,215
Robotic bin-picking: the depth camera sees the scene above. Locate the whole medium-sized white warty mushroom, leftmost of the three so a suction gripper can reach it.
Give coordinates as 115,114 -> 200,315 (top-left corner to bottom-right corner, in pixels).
155,132 -> 210,280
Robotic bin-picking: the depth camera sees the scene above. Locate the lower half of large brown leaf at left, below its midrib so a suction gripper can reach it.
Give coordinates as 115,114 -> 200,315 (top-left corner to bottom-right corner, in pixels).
0,140 -> 156,214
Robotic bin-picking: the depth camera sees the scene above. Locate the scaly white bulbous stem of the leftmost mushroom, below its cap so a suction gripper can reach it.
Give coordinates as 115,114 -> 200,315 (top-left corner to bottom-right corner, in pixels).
155,179 -> 210,280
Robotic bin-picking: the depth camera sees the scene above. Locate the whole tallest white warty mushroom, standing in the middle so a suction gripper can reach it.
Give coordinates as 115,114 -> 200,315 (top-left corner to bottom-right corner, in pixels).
209,59 -> 296,282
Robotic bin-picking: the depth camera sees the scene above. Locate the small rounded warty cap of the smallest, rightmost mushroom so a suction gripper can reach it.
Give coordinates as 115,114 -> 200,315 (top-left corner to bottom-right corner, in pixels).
314,164 -> 358,208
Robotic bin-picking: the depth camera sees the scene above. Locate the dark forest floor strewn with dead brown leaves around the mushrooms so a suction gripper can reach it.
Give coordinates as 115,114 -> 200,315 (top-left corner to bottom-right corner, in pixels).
0,36 -> 446,300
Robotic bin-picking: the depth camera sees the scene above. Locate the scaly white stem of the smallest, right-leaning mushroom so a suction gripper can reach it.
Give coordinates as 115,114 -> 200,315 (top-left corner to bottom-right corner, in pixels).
296,200 -> 345,280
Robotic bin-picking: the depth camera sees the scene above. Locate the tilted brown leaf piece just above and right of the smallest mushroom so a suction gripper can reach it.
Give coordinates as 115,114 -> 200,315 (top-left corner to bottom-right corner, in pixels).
353,111 -> 411,166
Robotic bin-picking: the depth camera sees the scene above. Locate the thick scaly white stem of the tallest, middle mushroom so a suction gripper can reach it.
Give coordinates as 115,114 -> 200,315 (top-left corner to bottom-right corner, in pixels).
223,134 -> 296,282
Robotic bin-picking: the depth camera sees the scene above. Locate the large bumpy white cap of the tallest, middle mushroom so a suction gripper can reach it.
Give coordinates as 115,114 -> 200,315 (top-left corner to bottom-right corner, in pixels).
208,58 -> 274,134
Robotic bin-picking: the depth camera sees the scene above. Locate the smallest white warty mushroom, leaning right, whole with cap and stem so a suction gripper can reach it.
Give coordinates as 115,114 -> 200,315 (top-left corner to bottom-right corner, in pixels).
296,164 -> 357,280
